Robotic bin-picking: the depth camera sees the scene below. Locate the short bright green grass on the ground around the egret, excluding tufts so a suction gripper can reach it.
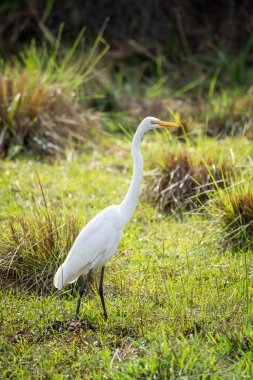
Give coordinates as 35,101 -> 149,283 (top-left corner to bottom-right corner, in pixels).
0,134 -> 253,379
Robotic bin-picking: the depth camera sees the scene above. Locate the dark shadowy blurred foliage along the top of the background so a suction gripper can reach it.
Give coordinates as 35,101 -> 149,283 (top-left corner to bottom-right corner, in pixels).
0,0 -> 253,62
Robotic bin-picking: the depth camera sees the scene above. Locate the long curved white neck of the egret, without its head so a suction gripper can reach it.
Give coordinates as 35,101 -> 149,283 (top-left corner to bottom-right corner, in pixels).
119,128 -> 145,227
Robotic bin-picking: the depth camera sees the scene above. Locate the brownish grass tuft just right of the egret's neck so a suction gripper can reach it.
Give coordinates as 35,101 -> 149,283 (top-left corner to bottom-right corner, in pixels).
147,149 -> 234,212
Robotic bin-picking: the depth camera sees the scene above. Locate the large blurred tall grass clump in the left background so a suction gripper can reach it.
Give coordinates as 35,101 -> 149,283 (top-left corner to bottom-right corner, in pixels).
0,27 -> 108,156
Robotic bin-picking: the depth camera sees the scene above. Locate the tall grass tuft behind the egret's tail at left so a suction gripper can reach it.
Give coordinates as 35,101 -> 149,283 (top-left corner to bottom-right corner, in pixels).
0,195 -> 79,293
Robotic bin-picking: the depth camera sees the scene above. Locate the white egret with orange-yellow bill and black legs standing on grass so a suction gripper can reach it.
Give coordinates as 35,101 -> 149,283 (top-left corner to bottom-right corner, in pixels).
54,117 -> 179,319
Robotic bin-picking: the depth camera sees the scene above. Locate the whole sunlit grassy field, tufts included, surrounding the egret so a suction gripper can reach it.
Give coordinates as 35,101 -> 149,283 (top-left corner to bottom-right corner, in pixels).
0,35 -> 253,380
